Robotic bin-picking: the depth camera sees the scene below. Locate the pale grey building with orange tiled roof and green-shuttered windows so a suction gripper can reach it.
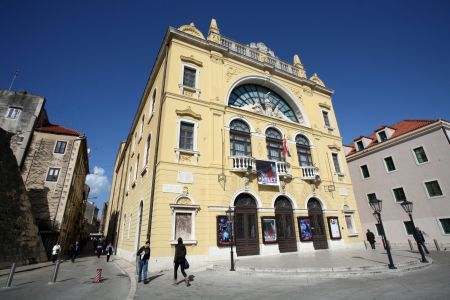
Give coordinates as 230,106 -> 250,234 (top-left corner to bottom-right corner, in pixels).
346,120 -> 450,247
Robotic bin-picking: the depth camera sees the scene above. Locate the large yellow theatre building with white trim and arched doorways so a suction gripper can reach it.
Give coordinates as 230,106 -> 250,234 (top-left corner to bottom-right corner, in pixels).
105,19 -> 363,268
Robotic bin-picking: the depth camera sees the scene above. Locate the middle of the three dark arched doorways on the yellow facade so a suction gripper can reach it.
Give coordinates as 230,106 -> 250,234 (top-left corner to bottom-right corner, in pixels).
275,196 -> 297,253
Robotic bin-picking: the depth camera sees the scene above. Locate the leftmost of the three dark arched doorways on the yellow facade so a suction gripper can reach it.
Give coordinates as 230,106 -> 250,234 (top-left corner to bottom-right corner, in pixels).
234,194 -> 259,256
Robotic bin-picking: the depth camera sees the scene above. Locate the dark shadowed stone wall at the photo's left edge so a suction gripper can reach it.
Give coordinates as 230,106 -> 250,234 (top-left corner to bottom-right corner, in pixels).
0,128 -> 47,269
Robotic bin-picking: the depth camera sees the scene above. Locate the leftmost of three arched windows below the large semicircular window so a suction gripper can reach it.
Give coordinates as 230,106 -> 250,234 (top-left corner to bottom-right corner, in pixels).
230,120 -> 252,156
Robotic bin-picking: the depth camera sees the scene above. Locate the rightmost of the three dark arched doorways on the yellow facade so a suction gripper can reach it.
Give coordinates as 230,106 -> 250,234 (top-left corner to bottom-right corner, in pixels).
308,198 -> 328,250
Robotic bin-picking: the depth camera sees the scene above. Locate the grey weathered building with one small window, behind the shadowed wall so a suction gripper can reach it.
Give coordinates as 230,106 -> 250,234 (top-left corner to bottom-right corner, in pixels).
0,90 -> 45,168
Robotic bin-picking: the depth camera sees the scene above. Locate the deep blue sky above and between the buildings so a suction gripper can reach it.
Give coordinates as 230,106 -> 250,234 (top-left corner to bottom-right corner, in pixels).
0,0 -> 450,207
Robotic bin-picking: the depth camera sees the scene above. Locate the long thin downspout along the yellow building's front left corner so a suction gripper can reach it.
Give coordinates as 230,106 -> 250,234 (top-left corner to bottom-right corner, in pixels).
147,42 -> 169,240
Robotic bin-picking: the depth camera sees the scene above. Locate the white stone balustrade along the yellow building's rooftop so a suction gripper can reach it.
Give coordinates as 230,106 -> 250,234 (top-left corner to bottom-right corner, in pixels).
220,37 -> 299,76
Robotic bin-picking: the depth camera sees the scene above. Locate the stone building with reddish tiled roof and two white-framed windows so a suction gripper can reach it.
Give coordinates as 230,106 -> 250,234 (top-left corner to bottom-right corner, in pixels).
22,114 -> 89,253
